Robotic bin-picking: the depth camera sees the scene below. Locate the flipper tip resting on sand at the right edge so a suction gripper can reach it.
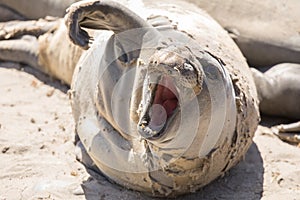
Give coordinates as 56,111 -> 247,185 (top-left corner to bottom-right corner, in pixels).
271,121 -> 300,143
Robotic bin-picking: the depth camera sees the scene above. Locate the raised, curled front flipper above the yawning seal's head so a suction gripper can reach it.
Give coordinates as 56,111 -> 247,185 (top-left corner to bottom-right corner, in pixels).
65,0 -> 152,49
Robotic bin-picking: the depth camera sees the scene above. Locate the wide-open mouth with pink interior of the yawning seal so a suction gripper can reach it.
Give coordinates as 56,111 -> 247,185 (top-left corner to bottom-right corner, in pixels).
139,75 -> 178,138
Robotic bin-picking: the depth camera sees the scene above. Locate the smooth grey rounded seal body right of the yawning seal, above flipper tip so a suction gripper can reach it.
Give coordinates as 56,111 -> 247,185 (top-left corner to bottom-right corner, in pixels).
252,63 -> 300,120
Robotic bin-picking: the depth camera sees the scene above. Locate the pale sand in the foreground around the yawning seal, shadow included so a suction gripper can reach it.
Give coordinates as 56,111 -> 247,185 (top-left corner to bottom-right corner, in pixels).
0,63 -> 300,200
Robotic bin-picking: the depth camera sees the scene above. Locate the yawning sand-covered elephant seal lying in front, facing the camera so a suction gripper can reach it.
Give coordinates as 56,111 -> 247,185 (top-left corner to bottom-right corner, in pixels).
0,0 -> 259,197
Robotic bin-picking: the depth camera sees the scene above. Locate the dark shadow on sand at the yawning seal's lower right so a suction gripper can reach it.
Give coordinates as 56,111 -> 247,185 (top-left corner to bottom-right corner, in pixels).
189,143 -> 264,200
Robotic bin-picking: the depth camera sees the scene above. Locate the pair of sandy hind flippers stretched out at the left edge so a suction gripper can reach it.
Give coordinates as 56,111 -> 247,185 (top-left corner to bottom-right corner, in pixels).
0,18 -> 59,72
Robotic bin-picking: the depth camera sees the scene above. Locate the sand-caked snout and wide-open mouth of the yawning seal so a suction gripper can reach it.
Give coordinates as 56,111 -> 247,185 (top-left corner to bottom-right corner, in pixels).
138,44 -> 204,139
